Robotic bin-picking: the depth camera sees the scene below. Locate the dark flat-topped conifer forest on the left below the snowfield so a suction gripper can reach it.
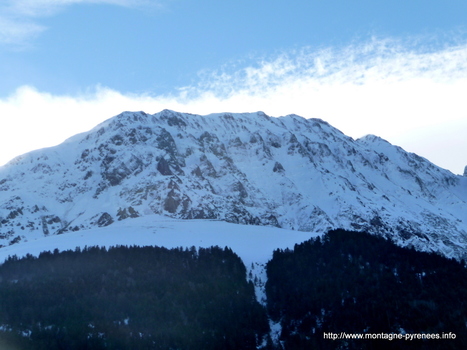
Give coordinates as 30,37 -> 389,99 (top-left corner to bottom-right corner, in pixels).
0,247 -> 269,350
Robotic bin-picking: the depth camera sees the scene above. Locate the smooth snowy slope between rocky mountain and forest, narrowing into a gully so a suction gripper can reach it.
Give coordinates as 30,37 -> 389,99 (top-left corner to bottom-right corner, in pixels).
0,215 -> 316,303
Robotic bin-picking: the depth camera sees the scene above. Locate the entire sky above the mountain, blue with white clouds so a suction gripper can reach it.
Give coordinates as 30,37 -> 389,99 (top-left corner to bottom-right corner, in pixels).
0,0 -> 467,173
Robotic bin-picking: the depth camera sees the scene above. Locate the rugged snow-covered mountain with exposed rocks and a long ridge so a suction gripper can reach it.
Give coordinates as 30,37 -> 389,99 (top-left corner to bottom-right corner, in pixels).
0,110 -> 467,258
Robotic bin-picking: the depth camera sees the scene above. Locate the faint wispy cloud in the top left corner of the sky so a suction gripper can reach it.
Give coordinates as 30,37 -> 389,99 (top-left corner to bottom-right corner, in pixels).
0,0 -> 152,47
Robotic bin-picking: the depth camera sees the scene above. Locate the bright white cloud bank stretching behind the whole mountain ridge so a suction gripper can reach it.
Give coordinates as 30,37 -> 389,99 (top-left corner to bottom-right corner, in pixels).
0,39 -> 467,173
